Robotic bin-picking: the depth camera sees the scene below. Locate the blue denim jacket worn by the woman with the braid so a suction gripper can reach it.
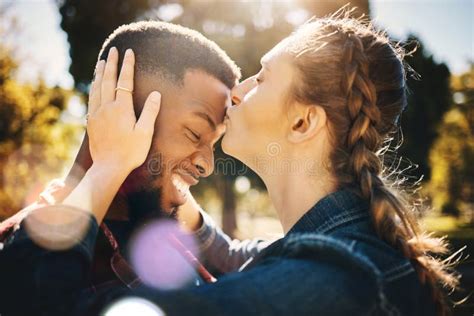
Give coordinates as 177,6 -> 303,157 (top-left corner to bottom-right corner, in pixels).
0,190 -> 435,315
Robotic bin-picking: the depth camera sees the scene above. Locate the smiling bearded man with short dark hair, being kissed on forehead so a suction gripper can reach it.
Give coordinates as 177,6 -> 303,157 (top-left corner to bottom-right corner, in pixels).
0,22 -> 240,312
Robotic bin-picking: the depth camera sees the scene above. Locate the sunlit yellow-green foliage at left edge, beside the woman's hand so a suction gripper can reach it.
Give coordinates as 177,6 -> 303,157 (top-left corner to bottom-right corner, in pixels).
0,45 -> 78,220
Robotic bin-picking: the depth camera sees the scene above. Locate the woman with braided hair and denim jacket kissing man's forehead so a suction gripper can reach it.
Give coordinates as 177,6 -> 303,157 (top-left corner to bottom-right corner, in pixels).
0,13 -> 458,315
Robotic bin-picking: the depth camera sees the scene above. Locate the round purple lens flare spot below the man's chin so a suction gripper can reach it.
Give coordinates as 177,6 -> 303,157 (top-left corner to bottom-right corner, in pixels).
130,220 -> 198,290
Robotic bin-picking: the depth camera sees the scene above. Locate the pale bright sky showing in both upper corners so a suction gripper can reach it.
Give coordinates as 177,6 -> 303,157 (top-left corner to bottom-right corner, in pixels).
4,0 -> 474,88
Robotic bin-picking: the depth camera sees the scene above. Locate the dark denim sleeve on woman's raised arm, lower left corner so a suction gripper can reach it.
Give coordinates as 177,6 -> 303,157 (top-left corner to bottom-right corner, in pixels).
0,208 -> 98,316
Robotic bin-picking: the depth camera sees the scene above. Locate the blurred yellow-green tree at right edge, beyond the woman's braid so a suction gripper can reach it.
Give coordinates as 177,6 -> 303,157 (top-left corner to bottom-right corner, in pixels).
430,63 -> 474,217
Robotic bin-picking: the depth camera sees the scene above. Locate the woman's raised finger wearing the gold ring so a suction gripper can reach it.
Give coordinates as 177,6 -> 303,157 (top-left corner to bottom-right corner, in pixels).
115,49 -> 135,105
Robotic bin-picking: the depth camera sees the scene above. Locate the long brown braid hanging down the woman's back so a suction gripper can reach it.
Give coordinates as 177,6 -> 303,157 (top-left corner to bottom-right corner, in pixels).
341,32 -> 456,315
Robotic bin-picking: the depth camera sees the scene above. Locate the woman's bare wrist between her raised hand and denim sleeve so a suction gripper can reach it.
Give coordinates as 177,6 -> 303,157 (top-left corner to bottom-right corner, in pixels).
63,163 -> 129,224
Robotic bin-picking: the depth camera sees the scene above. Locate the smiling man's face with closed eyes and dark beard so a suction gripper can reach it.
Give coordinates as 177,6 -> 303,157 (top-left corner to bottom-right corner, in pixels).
122,70 -> 230,213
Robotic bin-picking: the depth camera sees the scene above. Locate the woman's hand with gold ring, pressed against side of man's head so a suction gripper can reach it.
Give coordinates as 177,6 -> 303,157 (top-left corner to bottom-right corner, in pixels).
87,47 -> 161,174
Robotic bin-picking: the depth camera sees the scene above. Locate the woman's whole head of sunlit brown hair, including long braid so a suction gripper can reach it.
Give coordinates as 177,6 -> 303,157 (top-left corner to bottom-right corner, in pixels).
286,8 -> 459,315
